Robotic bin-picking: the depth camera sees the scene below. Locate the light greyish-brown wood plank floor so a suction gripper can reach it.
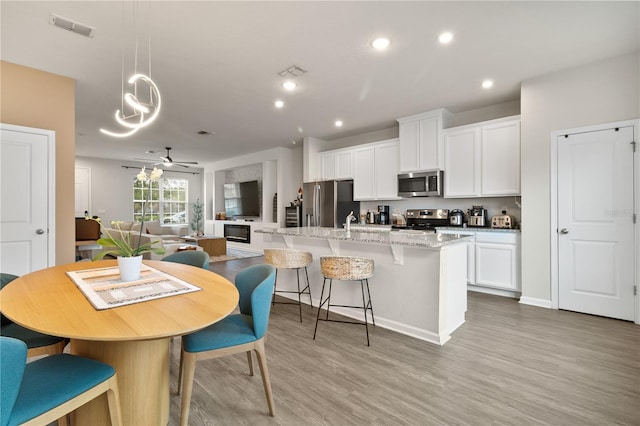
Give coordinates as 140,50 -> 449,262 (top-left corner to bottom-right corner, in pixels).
170,257 -> 640,426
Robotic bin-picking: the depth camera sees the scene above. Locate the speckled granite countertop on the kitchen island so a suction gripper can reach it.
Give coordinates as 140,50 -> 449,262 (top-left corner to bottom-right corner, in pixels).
256,227 -> 473,248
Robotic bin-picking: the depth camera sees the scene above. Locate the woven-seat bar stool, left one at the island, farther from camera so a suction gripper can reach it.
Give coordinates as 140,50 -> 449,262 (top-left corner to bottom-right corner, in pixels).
264,249 -> 313,322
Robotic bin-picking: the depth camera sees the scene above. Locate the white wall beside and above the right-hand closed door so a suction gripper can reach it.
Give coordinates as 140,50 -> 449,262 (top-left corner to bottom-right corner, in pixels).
521,52 -> 640,305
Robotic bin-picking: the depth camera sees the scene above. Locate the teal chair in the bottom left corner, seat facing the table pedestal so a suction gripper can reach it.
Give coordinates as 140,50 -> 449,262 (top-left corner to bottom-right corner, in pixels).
0,337 -> 122,426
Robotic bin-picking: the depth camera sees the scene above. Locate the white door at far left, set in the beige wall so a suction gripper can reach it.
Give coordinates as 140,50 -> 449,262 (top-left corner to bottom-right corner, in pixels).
0,124 -> 55,275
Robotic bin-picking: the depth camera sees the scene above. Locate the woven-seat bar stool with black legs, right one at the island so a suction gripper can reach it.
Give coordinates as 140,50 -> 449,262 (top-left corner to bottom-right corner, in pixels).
313,256 -> 376,346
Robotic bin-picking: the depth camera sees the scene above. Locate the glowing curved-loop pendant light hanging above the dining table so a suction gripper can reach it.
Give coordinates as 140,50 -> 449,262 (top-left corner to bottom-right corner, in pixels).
100,1 -> 162,138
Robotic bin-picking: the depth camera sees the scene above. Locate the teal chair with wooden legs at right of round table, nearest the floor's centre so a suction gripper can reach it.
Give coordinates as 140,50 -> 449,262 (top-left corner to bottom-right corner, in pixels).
178,264 -> 276,426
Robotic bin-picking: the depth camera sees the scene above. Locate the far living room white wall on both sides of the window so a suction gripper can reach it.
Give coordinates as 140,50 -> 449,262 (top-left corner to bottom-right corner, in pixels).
75,157 -> 203,228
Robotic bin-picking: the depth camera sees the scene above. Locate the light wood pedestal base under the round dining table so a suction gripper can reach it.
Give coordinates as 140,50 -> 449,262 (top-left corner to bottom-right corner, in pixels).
71,337 -> 170,426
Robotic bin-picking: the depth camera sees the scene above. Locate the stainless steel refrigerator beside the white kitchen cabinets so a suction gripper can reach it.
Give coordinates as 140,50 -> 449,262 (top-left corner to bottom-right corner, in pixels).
302,180 -> 360,228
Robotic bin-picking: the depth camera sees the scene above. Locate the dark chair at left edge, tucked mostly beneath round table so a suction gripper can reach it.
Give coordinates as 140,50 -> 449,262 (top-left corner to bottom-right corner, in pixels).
0,274 -> 67,357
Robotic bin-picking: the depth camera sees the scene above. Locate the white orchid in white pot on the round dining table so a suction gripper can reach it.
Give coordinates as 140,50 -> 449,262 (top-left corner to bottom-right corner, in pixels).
86,167 -> 165,281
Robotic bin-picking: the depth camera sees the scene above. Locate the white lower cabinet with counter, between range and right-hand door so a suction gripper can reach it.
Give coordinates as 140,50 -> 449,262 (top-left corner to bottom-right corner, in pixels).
438,228 -> 521,292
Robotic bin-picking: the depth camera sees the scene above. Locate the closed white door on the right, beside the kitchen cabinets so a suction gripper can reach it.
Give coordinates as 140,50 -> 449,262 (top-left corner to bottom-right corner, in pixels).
557,127 -> 635,320
